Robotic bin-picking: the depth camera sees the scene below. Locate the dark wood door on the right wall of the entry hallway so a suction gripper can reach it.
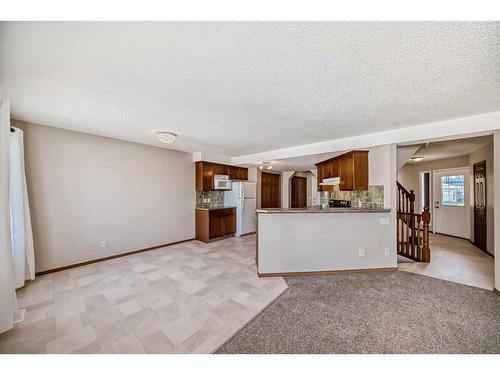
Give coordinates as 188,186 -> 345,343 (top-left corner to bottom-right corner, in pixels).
473,160 -> 487,251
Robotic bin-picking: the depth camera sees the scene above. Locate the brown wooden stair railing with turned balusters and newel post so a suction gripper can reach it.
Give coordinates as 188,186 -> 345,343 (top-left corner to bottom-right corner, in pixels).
396,182 -> 431,262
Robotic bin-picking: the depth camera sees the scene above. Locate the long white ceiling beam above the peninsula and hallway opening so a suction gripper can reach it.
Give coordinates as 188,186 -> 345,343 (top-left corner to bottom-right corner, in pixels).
231,111 -> 500,165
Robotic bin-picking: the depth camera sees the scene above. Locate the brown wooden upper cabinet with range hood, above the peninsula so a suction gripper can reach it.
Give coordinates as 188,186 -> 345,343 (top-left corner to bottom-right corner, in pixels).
316,151 -> 368,191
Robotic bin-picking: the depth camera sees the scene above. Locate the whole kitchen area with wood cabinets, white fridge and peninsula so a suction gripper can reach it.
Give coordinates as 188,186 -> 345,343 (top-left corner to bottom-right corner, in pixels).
196,146 -> 397,276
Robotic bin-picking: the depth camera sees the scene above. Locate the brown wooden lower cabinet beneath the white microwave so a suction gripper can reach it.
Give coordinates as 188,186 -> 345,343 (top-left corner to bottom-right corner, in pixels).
195,208 -> 236,242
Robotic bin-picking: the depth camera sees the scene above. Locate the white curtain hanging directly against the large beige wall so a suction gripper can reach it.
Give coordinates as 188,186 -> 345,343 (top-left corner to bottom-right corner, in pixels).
10,128 -> 35,289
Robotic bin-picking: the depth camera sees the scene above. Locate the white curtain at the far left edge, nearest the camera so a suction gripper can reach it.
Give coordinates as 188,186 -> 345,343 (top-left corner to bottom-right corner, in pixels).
0,97 -> 18,332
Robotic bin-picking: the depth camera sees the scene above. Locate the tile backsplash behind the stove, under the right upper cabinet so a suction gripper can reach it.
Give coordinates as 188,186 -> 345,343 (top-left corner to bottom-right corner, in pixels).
320,185 -> 384,208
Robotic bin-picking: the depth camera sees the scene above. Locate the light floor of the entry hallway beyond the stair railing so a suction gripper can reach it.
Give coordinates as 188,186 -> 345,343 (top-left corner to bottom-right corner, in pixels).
398,233 -> 495,290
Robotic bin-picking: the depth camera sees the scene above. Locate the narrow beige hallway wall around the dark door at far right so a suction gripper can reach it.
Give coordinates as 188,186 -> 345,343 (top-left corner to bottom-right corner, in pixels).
469,143 -> 495,254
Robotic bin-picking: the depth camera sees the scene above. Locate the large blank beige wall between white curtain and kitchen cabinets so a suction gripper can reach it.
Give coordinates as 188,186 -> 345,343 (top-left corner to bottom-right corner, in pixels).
13,121 -> 195,272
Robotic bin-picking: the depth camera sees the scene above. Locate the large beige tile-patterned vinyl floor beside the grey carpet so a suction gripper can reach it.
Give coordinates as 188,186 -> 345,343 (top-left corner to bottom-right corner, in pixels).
0,235 -> 287,353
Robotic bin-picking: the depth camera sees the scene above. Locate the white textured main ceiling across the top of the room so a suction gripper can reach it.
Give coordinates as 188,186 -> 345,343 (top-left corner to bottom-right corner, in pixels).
0,22 -> 500,156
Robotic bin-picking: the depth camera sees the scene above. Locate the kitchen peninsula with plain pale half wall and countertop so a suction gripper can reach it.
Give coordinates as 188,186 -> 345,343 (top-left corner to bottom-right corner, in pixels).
257,207 -> 397,276
